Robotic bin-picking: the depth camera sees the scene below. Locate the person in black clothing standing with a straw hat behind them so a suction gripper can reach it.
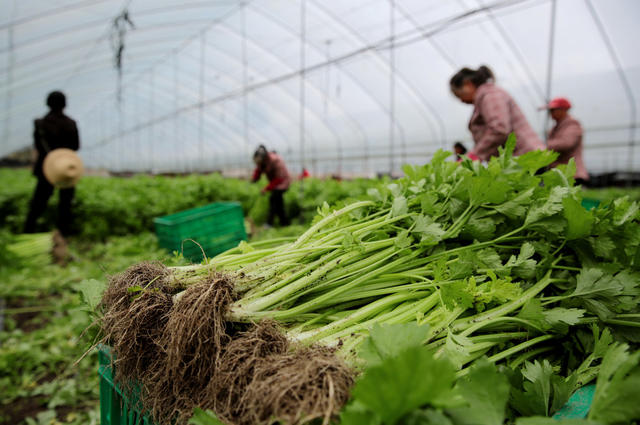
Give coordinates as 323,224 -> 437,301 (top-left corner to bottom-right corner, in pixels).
24,91 -> 80,235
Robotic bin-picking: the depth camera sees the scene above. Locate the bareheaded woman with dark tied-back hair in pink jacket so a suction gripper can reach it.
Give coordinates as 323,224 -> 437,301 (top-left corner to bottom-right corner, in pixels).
449,65 -> 545,161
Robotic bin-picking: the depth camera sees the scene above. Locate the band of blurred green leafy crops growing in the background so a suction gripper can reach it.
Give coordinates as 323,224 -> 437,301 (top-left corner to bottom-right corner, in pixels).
0,169 -> 377,240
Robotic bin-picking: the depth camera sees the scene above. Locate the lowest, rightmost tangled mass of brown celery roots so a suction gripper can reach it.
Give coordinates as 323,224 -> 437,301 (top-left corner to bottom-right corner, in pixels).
206,321 -> 355,425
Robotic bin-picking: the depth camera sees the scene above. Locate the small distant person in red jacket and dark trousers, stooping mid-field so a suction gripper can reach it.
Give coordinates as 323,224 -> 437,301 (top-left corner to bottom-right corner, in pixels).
251,145 -> 291,226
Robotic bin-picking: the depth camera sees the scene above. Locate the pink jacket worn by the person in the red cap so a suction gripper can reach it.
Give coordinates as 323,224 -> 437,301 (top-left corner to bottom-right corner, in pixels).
547,115 -> 589,180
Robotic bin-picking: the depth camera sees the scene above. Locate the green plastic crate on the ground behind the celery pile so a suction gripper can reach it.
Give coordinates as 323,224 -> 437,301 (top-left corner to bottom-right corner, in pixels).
154,202 -> 247,262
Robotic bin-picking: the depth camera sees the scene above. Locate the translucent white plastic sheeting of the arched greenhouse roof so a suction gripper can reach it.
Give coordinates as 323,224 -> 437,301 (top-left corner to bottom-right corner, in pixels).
0,0 -> 640,174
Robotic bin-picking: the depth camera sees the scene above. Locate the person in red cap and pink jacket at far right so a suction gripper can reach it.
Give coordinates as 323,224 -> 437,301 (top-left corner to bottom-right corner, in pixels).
543,97 -> 589,184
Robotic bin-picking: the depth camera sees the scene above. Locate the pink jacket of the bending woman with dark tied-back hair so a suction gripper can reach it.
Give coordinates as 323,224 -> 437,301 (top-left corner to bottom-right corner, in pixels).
469,83 -> 545,161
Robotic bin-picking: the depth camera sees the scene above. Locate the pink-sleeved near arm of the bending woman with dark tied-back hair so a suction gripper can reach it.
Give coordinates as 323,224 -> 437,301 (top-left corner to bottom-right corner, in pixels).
469,92 -> 511,161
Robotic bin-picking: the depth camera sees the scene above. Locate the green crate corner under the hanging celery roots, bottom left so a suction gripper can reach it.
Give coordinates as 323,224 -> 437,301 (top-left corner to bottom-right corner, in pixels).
98,345 -> 154,425
